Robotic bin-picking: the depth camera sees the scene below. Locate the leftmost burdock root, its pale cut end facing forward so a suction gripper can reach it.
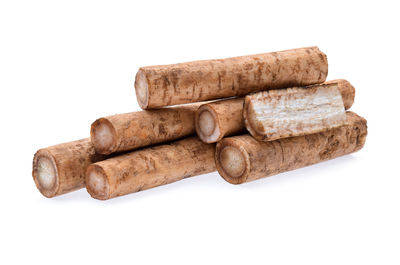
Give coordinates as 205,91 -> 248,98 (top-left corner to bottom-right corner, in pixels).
32,138 -> 106,198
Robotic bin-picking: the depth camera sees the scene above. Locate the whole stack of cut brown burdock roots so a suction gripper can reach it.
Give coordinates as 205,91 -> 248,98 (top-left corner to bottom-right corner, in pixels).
33,47 -> 367,200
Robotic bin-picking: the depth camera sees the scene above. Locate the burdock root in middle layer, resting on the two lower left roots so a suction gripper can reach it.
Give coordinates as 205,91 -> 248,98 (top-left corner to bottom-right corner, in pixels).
90,103 -> 201,154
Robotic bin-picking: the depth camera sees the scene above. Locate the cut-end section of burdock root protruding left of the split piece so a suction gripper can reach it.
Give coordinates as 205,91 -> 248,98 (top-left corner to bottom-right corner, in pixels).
195,98 -> 245,143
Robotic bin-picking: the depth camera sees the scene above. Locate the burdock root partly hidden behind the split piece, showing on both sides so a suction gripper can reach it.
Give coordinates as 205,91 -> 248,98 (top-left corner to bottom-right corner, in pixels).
195,79 -> 355,143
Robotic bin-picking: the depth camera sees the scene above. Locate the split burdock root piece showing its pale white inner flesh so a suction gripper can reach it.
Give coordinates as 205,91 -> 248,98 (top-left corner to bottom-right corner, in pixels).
243,83 -> 346,141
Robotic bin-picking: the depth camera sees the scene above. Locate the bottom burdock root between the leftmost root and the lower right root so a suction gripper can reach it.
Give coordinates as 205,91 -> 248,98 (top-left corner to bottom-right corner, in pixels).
86,137 -> 216,200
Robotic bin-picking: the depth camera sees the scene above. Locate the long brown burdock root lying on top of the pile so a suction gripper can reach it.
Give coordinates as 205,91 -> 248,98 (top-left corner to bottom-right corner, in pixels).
135,47 -> 328,109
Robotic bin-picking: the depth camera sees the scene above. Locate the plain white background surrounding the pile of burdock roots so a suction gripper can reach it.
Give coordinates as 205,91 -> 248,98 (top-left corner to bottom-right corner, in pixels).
0,0 -> 400,264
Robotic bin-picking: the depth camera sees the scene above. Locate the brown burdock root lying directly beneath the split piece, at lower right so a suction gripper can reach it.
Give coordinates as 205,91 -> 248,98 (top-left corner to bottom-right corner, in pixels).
215,112 -> 367,184
